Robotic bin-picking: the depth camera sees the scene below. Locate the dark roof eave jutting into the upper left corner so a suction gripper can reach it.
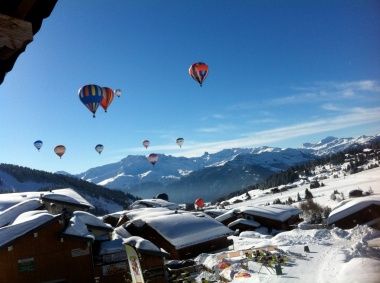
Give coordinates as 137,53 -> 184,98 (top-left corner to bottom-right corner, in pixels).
0,0 -> 57,84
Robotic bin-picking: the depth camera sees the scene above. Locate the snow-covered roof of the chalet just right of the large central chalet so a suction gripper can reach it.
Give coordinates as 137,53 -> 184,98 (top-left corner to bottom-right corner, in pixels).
239,204 -> 301,222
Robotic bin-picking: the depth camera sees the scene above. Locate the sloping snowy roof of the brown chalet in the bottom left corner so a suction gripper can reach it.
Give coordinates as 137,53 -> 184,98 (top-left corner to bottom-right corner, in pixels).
0,210 -> 58,247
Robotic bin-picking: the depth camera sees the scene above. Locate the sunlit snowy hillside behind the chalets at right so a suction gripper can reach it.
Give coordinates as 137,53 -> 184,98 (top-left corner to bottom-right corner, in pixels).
228,167 -> 380,211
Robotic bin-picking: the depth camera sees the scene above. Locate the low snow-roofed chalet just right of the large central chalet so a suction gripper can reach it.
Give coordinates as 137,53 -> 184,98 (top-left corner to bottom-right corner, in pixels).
215,204 -> 301,230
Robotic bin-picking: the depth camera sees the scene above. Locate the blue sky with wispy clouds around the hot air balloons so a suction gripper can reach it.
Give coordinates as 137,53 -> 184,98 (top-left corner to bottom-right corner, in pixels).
0,0 -> 380,173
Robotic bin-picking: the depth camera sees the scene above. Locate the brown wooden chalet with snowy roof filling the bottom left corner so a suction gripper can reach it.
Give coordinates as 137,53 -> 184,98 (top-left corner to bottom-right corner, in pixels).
0,210 -> 93,283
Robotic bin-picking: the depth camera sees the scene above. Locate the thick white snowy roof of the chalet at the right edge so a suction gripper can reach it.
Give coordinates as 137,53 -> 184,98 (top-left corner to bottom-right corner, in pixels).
327,196 -> 380,225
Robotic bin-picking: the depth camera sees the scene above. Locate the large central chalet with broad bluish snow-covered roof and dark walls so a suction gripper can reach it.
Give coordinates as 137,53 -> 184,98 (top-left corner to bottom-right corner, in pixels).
124,211 -> 233,259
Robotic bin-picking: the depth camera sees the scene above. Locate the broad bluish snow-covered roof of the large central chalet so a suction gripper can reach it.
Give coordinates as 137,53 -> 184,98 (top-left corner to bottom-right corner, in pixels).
143,213 -> 233,249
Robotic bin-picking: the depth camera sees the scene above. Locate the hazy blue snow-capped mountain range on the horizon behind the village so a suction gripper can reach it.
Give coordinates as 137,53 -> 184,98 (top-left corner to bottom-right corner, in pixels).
77,135 -> 380,203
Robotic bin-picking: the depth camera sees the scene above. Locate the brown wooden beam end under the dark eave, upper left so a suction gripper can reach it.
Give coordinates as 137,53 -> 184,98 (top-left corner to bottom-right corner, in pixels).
0,14 -> 33,60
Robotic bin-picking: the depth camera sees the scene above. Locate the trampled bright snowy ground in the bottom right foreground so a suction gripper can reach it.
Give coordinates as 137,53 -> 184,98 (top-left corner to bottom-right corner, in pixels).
196,226 -> 380,283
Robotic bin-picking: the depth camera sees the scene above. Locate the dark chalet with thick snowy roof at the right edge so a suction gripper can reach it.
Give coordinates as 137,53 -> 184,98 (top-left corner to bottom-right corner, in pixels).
327,195 -> 380,229
